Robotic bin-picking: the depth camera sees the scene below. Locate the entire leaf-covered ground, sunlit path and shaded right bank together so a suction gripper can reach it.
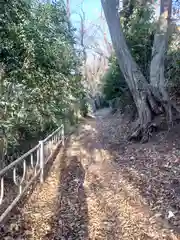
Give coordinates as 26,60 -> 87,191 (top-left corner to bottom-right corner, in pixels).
1,109 -> 180,240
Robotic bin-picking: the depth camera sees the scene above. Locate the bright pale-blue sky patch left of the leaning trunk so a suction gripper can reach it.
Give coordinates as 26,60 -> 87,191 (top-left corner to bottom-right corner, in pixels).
69,0 -> 111,61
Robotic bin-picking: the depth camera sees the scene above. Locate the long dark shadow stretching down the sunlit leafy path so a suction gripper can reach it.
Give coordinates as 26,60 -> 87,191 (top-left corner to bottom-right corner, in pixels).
44,140 -> 88,240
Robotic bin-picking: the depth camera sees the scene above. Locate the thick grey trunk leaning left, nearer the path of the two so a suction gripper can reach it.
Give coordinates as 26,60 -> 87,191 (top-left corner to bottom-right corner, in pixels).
101,0 -> 158,140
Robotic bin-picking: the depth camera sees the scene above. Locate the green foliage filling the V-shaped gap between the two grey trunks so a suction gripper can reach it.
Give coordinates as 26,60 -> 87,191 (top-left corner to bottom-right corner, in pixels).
121,4 -> 156,79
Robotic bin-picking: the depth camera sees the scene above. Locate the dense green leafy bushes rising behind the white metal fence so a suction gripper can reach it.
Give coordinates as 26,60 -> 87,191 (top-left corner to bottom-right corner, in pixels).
0,0 -> 86,165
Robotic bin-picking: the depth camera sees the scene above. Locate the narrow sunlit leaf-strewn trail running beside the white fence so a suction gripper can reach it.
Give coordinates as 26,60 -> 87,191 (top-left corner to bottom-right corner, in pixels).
2,111 -> 180,240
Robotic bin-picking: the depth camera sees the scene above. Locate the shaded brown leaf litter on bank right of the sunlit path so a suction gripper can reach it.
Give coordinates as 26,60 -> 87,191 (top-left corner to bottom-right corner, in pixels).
95,109 -> 180,239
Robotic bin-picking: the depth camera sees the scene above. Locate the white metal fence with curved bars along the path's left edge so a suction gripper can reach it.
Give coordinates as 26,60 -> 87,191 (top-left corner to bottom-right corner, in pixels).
0,125 -> 64,223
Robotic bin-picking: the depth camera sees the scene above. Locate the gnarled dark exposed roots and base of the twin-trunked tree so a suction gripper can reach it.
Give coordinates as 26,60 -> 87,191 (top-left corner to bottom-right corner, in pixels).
128,88 -> 180,143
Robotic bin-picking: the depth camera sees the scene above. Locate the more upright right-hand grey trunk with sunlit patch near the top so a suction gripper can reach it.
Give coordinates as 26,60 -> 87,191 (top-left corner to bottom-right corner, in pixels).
150,0 -> 178,125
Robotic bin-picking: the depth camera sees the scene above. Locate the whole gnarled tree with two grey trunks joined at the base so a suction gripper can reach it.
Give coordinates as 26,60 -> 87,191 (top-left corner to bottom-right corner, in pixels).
101,0 -> 178,141
